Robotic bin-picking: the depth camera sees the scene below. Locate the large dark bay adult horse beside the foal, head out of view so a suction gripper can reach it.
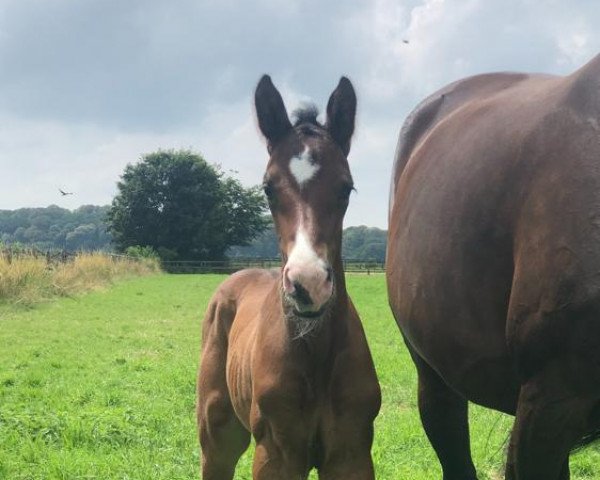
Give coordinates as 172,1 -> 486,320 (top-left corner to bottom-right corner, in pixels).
387,57 -> 600,480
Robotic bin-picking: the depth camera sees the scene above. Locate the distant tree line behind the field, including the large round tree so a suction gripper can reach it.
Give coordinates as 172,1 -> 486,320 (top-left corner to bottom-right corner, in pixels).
0,150 -> 386,261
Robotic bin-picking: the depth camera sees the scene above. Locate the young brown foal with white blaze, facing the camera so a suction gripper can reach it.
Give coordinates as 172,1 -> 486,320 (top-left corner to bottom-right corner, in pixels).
197,76 -> 380,480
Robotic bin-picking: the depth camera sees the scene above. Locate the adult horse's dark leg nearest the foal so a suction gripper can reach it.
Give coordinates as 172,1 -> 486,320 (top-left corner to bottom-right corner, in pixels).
407,342 -> 477,480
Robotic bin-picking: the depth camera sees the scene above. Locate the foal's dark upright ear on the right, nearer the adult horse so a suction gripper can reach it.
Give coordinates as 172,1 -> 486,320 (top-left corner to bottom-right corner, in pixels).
325,77 -> 356,155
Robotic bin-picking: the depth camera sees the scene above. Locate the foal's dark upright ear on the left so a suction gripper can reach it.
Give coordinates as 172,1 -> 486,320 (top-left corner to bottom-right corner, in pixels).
254,75 -> 292,151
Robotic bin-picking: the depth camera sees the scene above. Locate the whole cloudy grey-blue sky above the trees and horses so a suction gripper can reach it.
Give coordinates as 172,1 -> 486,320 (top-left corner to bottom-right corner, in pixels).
0,0 -> 600,228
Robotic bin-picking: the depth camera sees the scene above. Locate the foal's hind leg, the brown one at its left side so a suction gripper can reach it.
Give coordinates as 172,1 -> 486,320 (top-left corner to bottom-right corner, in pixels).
197,301 -> 250,480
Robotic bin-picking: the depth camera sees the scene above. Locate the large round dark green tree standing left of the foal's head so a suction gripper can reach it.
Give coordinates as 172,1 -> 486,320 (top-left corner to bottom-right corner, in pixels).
108,150 -> 266,260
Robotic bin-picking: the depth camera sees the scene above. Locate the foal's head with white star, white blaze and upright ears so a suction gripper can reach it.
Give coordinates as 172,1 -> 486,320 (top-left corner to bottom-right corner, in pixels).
255,75 -> 356,318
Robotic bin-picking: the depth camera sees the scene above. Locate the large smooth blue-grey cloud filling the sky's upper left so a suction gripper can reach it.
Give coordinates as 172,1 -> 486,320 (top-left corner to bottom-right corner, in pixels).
0,0 -> 372,131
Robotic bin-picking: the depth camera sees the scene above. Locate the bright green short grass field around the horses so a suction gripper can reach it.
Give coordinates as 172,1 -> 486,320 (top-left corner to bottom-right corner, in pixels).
0,275 -> 600,480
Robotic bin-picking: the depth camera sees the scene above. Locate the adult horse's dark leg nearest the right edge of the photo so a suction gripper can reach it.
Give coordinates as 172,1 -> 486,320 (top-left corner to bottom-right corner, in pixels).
506,359 -> 594,480
